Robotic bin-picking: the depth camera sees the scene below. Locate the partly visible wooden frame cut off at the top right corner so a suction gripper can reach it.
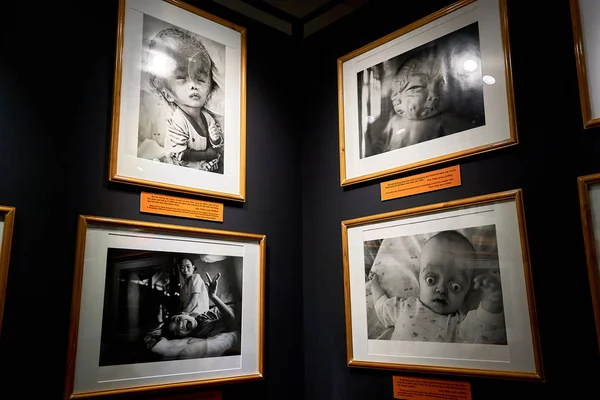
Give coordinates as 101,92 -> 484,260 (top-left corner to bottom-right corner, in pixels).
570,0 -> 600,129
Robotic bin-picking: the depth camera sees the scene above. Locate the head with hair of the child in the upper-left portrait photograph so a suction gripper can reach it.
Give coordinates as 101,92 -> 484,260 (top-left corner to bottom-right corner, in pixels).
148,28 -> 217,108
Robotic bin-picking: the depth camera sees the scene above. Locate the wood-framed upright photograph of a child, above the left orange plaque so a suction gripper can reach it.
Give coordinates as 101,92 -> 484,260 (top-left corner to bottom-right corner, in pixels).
109,0 -> 246,201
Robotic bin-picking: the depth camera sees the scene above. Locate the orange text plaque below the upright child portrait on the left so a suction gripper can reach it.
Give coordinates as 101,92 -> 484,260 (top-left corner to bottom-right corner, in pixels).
140,192 -> 223,222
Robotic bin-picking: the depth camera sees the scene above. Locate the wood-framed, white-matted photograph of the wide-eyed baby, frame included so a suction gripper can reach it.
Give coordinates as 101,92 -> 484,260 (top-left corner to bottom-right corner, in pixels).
341,189 -> 543,380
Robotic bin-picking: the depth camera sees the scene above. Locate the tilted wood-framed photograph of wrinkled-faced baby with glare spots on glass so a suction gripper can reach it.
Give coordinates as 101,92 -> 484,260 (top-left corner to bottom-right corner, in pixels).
338,0 -> 518,186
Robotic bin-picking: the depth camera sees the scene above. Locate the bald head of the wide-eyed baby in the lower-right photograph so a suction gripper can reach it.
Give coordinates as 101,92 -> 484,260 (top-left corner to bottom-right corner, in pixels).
419,231 -> 476,315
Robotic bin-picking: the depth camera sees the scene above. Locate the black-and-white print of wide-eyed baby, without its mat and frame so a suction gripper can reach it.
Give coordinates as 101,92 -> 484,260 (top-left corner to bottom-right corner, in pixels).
364,225 -> 507,345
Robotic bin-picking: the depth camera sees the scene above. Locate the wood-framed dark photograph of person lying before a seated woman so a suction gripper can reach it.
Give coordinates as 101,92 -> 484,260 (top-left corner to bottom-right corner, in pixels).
65,216 -> 266,399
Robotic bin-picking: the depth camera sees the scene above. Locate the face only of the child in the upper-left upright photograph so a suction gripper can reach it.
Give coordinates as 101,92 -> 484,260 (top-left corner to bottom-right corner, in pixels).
164,51 -> 212,108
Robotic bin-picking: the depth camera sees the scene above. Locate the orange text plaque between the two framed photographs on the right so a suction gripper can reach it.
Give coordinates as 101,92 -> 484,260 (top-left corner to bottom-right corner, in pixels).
381,165 -> 460,201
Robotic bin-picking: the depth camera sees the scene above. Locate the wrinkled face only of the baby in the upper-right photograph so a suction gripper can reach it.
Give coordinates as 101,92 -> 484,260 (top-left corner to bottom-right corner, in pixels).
390,60 -> 443,119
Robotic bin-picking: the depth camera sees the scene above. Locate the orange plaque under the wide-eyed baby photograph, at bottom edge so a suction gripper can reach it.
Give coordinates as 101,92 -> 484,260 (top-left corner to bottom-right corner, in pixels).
393,376 -> 471,400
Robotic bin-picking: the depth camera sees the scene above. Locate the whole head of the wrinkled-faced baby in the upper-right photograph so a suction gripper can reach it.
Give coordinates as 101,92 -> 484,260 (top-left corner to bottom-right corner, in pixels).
390,47 -> 448,120
